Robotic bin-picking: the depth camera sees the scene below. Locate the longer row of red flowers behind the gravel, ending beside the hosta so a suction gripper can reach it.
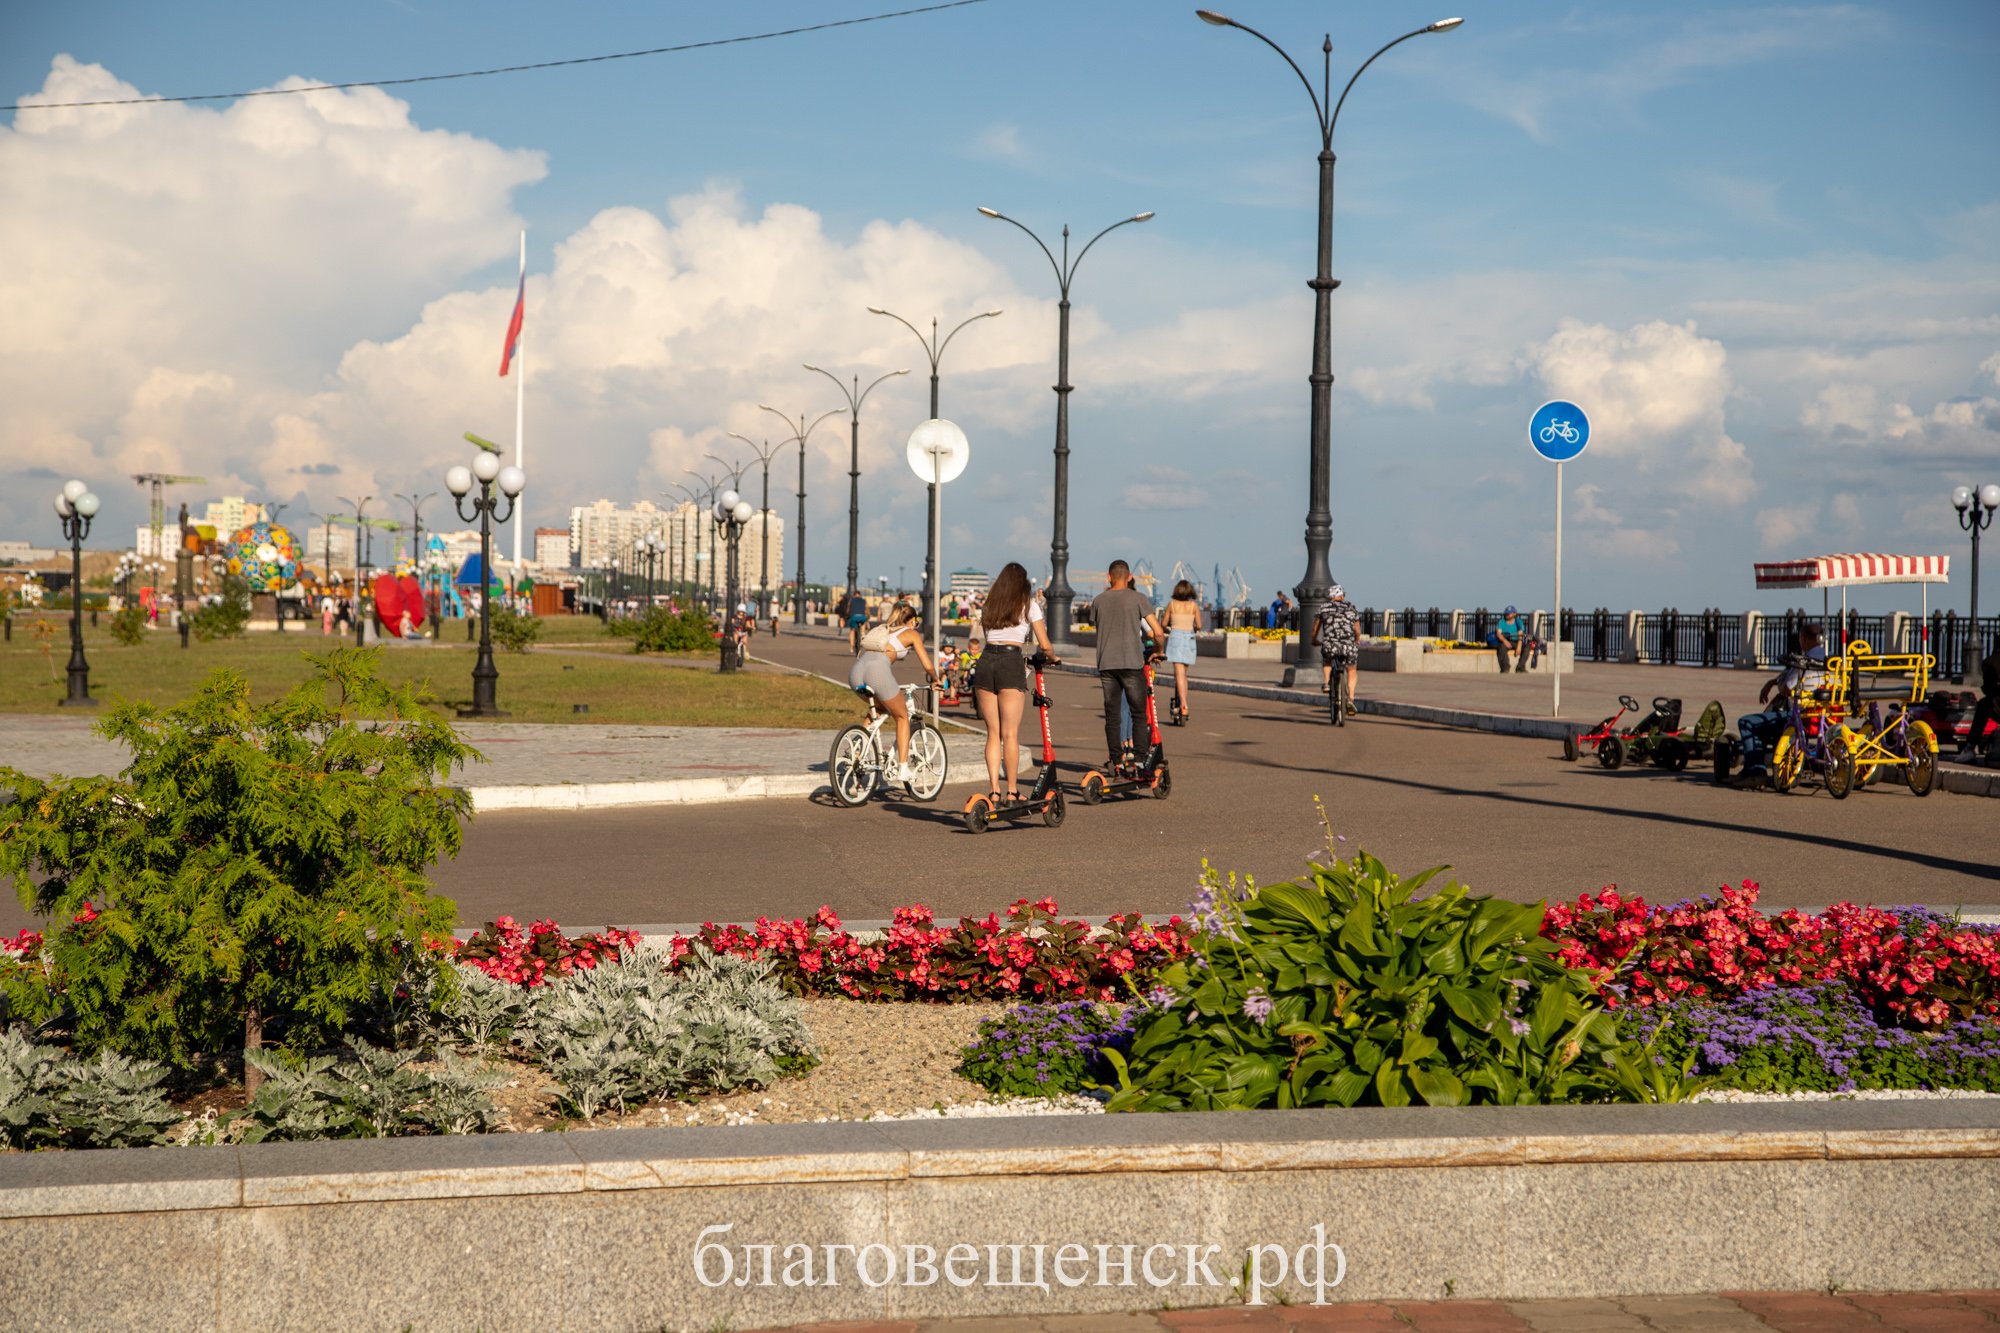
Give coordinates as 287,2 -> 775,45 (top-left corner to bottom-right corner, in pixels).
670,899 -> 1192,1001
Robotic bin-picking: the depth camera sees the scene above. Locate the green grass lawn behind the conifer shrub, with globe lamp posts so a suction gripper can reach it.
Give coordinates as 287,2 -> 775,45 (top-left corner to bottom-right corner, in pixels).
0,616 -> 856,731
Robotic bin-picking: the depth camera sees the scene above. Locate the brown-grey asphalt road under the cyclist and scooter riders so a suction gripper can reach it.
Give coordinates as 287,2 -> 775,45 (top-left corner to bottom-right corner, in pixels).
436,634 -> 2000,927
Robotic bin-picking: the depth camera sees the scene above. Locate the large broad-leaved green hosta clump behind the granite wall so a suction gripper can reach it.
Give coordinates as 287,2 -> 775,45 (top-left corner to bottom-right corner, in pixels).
1108,853 -> 1646,1111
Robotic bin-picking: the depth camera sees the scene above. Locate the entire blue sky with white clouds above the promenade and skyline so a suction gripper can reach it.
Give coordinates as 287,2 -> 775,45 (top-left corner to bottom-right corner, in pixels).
0,0 -> 2000,606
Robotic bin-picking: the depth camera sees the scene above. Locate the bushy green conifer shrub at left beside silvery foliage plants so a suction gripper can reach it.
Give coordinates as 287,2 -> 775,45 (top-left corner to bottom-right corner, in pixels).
0,648 -> 478,1091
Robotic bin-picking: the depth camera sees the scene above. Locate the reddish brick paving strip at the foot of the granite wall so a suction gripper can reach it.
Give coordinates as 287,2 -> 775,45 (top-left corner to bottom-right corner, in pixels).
752,1291 -> 2000,1333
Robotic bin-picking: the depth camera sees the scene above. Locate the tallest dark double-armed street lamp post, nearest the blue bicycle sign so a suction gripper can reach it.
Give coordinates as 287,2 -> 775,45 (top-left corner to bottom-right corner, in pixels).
1192,10 -> 1464,640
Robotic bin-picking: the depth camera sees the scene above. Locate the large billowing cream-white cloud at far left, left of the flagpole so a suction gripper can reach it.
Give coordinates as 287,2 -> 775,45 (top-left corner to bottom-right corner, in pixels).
0,56 -> 544,498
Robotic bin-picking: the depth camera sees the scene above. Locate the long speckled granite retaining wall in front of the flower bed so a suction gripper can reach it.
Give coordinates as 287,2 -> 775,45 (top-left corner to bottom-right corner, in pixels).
0,1099 -> 2000,1331
